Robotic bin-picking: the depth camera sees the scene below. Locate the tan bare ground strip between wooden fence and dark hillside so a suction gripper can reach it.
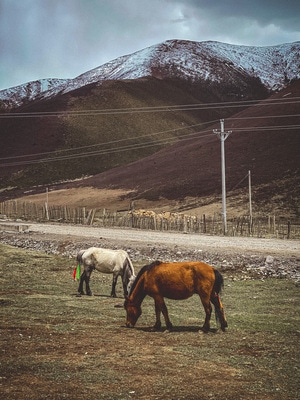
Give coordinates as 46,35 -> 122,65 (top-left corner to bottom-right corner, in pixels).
9,180 -> 297,220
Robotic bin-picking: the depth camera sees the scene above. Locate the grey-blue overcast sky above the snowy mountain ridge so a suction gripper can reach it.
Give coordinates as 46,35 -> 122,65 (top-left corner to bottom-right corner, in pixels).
0,0 -> 300,90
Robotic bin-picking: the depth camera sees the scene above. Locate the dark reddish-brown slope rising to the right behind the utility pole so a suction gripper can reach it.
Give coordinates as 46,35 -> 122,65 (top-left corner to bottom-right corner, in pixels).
55,81 -> 300,214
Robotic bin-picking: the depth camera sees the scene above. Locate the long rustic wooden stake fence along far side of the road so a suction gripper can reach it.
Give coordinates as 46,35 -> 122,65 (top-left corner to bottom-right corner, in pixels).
0,200 -> 300,239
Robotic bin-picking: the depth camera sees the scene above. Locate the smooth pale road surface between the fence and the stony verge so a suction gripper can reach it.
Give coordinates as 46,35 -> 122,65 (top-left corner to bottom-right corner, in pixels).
7,222 -> 300,255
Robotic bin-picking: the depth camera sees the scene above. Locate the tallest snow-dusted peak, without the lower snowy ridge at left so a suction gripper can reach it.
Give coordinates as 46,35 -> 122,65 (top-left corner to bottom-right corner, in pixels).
73,40 -> 300,90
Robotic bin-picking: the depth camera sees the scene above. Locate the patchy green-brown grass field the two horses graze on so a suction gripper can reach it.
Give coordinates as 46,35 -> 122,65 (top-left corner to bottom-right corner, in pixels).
0,244 -> 300,400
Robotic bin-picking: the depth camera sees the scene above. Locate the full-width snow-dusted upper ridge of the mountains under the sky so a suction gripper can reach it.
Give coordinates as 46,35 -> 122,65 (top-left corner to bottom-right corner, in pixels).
0,40 -> 300,109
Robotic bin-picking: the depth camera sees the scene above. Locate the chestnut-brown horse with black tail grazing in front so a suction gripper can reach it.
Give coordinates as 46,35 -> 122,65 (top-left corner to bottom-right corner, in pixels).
124,261 -> 227,332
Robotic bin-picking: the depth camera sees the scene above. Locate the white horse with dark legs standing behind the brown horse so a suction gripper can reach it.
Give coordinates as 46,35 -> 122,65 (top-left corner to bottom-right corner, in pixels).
77,247 -> 135,297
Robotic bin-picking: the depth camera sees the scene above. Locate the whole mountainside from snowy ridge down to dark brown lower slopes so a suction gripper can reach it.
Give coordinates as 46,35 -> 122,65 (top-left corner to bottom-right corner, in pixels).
0,40 -> 300,216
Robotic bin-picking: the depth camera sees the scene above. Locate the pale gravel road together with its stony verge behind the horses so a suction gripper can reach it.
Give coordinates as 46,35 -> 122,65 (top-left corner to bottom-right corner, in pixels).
0,221 -> 300,285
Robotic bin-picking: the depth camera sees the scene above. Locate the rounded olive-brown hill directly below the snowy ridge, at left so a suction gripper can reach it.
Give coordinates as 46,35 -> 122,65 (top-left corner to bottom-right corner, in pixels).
0,78 -> 240,188
